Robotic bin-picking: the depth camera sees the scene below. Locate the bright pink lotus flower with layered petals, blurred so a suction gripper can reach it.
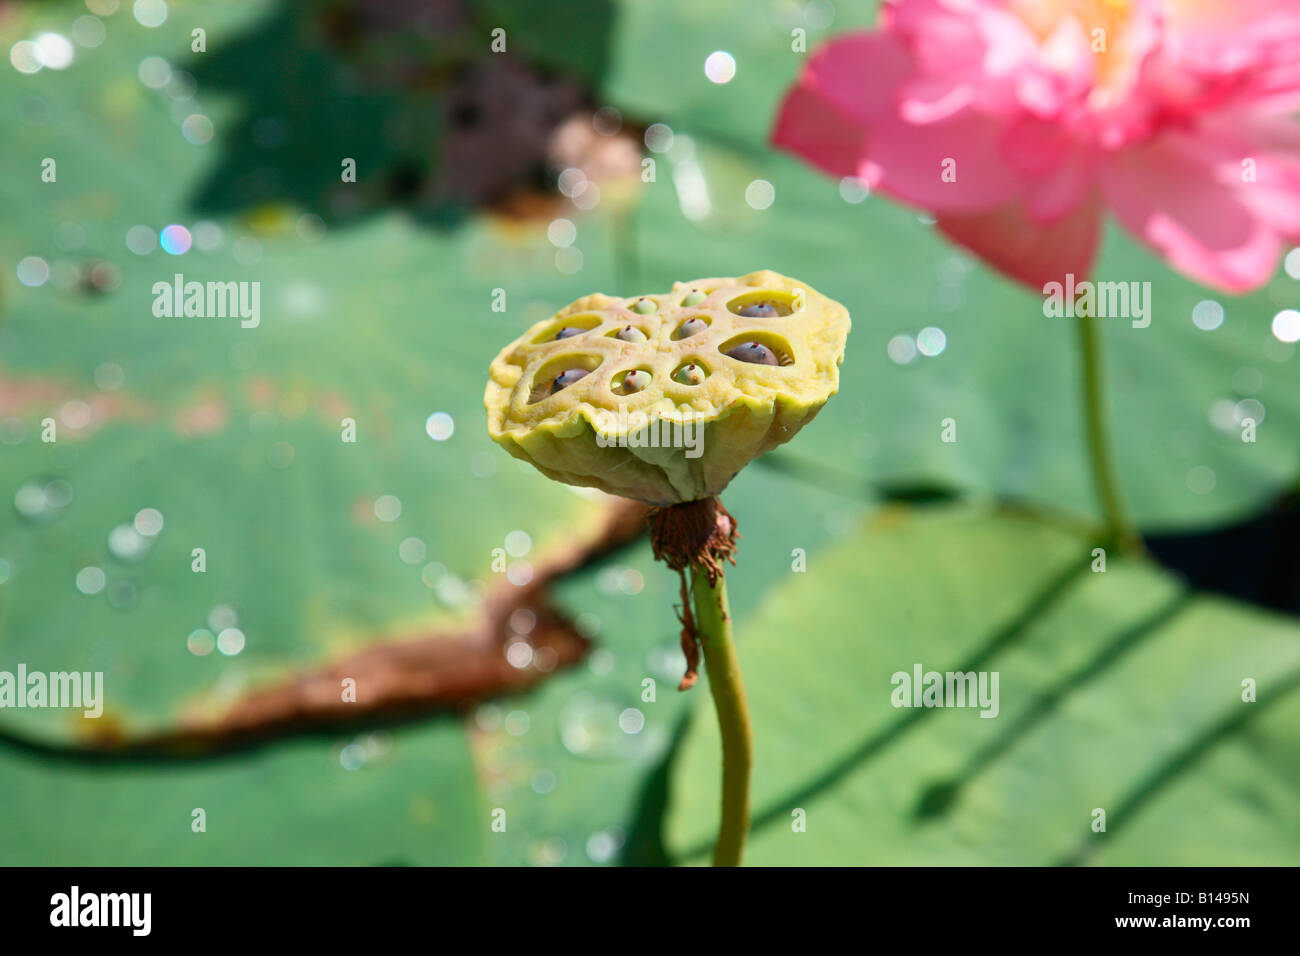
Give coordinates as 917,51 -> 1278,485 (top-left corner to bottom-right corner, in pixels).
772,0 -> 1300,291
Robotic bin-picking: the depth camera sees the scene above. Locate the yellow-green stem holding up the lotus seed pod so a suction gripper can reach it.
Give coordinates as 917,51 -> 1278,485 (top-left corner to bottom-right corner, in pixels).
690,564 -> 754,866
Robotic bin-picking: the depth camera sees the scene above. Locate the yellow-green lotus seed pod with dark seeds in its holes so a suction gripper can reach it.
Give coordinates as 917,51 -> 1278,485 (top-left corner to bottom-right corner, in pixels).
484,272 -> 849,506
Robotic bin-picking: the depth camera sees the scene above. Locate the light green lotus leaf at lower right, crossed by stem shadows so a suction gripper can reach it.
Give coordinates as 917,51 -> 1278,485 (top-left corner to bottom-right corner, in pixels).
666,507 -> 1300,865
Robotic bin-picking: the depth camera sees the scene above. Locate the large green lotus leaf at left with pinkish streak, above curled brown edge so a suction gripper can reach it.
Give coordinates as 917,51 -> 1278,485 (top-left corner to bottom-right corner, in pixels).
0,4 -> 629,736
